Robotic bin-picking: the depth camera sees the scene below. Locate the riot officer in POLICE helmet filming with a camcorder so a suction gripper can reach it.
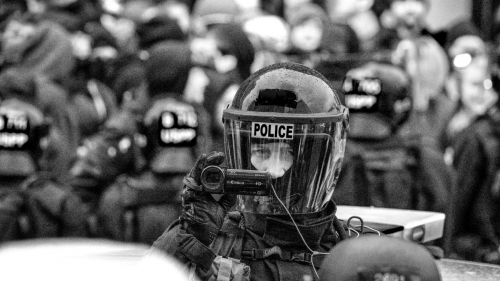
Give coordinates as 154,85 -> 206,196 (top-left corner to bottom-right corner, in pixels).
151,63 -> 348,280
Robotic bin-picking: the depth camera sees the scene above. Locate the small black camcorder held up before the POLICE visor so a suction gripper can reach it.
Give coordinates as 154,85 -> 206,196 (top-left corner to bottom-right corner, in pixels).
201,166 -> 271,196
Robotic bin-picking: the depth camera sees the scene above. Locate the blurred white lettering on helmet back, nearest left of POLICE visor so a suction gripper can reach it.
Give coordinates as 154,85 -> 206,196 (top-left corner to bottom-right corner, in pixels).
158,110 -> 198,146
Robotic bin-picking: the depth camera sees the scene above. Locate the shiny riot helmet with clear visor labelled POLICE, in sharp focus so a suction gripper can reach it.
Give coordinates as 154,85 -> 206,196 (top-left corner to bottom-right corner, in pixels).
223,63 -> 348,214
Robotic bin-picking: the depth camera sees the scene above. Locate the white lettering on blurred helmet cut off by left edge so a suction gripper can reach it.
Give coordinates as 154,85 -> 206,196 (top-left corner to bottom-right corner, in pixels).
0,115 -> 29,150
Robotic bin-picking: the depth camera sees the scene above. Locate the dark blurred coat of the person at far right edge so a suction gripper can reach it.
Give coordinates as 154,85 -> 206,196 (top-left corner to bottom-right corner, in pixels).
445,111 -> 500,252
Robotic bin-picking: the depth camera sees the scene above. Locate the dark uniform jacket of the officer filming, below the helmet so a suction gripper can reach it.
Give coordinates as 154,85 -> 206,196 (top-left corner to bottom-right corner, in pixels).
152,201 -> 346,281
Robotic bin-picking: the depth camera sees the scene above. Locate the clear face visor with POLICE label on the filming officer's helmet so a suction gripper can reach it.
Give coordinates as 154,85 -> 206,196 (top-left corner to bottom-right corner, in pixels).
224,116 -> 345,214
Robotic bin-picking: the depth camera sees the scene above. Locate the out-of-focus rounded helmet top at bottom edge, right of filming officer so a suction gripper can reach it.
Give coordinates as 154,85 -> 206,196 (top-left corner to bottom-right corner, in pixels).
318,234 -> 441,281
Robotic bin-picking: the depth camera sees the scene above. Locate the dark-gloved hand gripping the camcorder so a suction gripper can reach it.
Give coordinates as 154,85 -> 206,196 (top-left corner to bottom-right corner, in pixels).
181,151 -> 234,246
